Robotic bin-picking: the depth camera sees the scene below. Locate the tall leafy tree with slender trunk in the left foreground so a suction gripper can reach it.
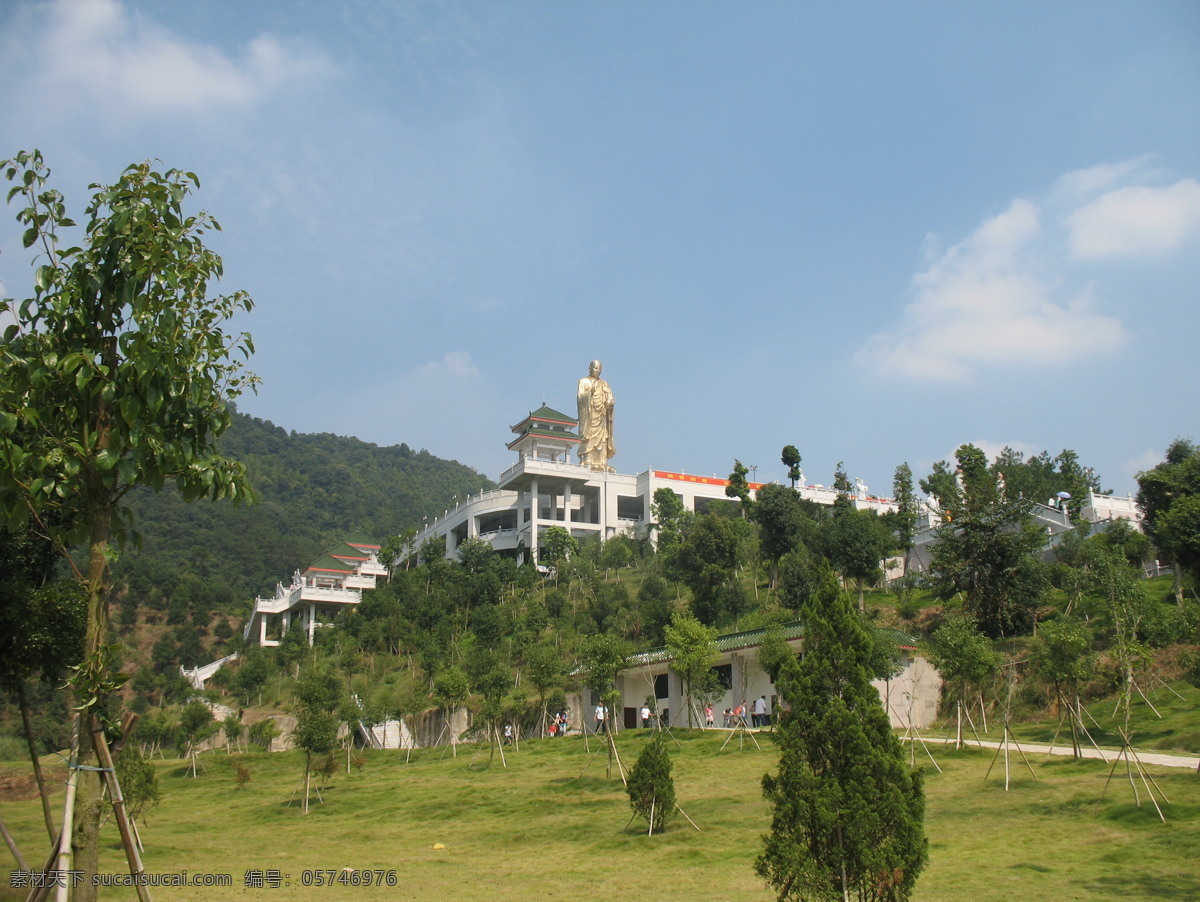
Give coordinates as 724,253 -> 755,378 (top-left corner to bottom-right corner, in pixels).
0,151 -> 257,900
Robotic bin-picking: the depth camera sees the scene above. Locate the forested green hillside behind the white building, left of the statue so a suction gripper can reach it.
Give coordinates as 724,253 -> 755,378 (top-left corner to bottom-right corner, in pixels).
114,414 -> 492,619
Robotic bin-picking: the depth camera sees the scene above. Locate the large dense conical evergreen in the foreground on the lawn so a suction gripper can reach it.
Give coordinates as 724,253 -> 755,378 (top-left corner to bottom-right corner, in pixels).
755,593 -> 928,902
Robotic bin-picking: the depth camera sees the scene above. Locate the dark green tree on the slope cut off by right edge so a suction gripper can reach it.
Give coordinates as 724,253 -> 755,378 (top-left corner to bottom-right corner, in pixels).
1138,439 -> 1200,601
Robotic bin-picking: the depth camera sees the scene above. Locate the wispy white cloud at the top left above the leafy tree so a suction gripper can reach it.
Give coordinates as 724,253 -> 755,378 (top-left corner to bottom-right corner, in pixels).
35,0 -> 332,114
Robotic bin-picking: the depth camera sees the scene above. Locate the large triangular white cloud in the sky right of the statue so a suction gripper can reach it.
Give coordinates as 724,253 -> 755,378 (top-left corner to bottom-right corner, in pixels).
856,198 -> 1127,379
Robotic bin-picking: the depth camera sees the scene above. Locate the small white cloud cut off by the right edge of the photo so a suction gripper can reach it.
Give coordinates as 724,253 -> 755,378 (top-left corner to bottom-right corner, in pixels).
1067,179 -> 1200,259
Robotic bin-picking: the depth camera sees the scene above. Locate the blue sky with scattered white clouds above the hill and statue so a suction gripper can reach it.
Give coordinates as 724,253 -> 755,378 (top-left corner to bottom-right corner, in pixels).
0,0 -> 1200,494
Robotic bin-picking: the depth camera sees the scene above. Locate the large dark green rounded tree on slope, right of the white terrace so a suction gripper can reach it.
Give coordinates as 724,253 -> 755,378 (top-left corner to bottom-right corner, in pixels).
929,445 -> 1048,638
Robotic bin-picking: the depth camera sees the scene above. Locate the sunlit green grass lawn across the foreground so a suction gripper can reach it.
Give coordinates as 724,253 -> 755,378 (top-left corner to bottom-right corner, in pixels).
0,730 -> 1200,902
